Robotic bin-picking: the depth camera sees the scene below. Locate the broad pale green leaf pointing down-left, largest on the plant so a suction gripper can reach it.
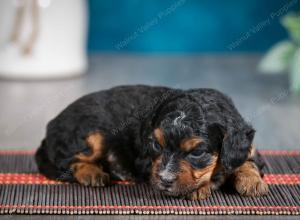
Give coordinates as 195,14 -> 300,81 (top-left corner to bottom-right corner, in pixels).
258,41 -> 296,74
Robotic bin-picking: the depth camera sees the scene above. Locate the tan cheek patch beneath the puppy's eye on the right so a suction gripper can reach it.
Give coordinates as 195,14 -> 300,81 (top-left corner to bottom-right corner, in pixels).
178,156 -> 217,187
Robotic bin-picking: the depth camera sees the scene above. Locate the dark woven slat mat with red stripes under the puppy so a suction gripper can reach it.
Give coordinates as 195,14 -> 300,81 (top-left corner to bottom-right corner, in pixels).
0,151 -> 300,215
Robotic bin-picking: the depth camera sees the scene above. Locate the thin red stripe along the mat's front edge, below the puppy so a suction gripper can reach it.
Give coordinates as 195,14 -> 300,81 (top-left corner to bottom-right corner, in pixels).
0,205 -> 300,210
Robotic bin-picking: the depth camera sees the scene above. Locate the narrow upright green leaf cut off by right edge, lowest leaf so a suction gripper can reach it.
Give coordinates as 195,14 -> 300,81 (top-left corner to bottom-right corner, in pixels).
289,49 -> 300,93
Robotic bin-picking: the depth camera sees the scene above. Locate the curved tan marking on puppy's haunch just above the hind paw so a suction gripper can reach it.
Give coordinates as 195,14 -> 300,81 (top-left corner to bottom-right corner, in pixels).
76,132 -> 104,163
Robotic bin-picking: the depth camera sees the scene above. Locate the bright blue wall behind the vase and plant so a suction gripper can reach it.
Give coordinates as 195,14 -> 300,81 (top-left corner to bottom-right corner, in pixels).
88,0 -> 300,52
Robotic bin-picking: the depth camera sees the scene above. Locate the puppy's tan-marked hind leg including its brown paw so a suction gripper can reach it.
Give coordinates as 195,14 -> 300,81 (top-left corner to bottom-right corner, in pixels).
71,132 -> 110,186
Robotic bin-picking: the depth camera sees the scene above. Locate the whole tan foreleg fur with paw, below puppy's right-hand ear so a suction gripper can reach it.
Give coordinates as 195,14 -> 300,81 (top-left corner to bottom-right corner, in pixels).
233,161 -> 268,196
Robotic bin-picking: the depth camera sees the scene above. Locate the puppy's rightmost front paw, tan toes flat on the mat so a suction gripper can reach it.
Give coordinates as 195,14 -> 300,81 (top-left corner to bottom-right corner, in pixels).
235,175 -> 269,197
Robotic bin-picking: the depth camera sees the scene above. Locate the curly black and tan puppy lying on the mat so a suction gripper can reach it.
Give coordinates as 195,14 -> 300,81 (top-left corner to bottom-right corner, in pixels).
36,86 -> 268,199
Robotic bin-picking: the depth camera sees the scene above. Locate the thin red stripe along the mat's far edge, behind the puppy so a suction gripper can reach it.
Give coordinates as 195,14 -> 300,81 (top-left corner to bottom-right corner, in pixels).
0,149 -> 300,156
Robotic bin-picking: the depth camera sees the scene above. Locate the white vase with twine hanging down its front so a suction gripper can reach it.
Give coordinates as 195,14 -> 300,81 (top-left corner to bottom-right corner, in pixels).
0,0 -> 87,79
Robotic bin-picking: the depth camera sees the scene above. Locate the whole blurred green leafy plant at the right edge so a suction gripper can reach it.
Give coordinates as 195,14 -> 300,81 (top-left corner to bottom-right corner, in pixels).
258,12 -> 300,93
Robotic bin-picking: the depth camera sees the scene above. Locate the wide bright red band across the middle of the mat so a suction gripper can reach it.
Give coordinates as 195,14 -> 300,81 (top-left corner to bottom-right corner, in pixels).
0,173 -> 300,185
